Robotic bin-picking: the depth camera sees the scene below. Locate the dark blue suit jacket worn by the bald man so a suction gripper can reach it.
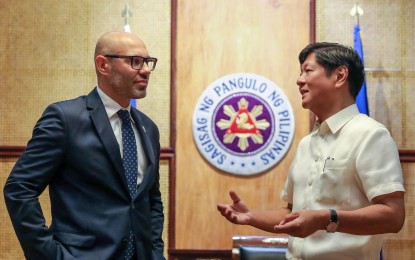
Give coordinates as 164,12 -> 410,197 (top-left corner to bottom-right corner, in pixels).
4,89 -> 164,260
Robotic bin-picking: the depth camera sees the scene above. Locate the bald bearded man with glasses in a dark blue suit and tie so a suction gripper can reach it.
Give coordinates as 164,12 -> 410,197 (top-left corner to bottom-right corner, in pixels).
4,32 -> 164,260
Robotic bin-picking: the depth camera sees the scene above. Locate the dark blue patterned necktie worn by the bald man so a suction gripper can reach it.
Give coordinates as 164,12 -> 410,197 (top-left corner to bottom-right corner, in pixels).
117,110 -> 138,259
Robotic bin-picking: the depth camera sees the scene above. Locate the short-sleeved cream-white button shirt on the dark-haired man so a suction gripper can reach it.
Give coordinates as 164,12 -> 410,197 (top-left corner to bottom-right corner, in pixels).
281,104 -> 404,260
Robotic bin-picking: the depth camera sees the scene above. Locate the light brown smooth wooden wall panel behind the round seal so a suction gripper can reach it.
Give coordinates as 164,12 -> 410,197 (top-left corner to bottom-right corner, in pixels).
175,0 -> 310,249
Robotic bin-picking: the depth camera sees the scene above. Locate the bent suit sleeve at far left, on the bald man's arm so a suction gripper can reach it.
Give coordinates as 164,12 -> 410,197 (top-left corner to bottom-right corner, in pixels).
3,104 -> 66,259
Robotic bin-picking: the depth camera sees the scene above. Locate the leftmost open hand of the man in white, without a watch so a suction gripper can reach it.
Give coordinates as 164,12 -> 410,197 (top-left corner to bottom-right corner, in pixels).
217,191 -> 251,225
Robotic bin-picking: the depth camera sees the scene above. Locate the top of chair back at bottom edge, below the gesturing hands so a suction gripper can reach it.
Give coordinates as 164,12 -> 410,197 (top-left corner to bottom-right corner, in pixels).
232,236 -> 288,260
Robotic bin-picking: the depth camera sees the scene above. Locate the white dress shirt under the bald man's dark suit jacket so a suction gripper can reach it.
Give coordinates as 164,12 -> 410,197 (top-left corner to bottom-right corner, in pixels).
97,87 -> 148,185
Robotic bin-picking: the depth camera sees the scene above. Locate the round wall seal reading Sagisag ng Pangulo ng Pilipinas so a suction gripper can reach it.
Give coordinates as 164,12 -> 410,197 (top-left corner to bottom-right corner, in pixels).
192,73 -> 294,176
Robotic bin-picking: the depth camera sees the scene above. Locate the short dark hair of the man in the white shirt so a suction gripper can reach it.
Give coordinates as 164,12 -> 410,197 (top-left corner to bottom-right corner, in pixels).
298,42 -> 365,99
